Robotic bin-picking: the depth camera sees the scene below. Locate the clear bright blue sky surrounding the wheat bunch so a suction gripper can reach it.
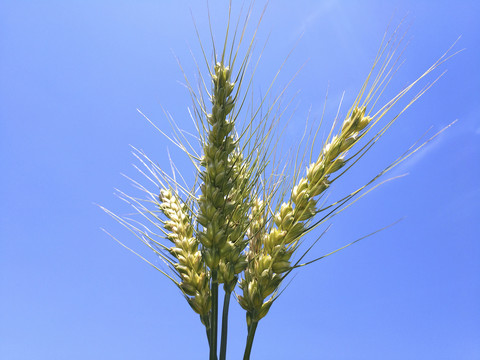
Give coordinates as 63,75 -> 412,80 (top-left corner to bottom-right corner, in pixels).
0,0 -> 480,360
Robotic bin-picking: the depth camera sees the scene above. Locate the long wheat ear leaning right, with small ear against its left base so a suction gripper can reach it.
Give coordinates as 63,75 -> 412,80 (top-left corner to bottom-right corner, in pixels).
239,107 -> 371,322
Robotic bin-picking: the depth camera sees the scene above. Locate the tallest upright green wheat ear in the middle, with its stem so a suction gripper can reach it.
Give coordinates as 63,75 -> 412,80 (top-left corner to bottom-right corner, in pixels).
197,62 -> 240,360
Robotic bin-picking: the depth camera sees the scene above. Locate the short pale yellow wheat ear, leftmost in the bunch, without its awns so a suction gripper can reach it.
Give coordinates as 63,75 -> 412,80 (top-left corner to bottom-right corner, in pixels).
159,190 -> 211,318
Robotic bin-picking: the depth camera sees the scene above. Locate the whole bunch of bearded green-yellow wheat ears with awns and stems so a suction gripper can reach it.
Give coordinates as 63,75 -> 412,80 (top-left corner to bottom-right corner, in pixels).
104,3 -> 458,360
